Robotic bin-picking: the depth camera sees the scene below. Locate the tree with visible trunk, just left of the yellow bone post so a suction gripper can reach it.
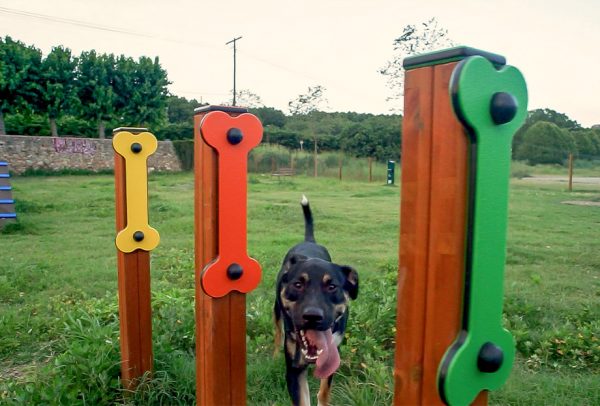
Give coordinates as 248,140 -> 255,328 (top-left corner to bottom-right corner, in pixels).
76,51 -> 116,138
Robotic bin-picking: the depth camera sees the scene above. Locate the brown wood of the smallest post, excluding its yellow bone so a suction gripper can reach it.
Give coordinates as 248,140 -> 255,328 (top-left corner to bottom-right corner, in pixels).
113,128 -> 153,389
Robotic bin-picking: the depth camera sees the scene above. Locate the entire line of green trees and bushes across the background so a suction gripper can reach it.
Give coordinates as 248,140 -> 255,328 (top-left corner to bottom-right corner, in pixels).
0,33 -> 600,164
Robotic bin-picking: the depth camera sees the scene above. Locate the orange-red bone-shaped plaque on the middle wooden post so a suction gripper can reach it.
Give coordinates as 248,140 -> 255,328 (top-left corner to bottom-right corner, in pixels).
200,111 -> 263,297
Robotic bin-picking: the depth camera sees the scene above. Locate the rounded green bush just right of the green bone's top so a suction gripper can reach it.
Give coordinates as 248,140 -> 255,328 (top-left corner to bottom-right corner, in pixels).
515,121 -> 575,165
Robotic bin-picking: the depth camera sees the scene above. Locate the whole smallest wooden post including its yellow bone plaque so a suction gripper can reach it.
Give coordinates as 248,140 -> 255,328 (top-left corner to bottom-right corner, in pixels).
113,128 -> 158,389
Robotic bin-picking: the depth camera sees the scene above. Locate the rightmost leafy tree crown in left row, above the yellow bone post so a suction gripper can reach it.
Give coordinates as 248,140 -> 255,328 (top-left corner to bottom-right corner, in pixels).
114,55 -> 169,127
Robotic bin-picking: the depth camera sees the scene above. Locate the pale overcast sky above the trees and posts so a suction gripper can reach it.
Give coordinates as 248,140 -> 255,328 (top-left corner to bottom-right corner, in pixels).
0,0 -> 600,126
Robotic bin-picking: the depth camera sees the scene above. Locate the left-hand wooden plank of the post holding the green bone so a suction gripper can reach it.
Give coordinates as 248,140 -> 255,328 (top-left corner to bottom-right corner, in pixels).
394,67 -> 433,405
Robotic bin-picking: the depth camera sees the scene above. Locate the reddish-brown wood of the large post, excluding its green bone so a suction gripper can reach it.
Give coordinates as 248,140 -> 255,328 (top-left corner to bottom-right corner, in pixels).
394,49 -> 504,405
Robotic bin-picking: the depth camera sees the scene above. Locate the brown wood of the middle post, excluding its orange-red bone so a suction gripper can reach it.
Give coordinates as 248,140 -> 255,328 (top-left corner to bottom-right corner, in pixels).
194,106 -> 260,406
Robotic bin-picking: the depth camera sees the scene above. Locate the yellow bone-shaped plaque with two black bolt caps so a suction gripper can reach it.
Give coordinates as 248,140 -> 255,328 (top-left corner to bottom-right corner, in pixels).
113,131 -> 160,252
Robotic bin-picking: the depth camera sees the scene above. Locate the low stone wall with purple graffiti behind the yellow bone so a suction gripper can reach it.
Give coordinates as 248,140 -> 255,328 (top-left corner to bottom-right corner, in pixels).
0,135 -> 181,175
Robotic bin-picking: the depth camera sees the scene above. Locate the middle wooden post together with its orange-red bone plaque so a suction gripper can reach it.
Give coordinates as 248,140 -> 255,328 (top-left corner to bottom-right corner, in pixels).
194,106 -> 262,406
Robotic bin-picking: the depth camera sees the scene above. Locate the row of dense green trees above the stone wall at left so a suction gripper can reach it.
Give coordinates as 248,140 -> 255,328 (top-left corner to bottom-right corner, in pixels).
0,36 -> 169,138
